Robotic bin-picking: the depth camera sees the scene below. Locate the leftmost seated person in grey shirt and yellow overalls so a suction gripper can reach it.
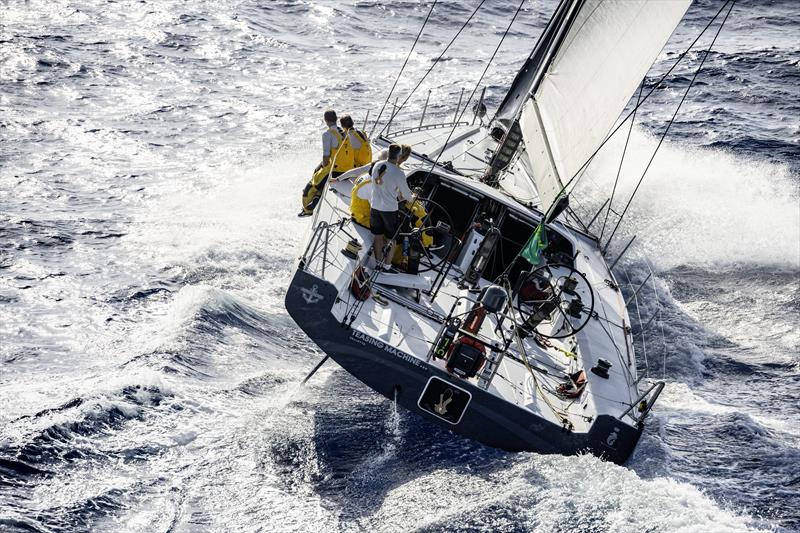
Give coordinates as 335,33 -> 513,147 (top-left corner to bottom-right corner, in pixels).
298,109 -> 355,217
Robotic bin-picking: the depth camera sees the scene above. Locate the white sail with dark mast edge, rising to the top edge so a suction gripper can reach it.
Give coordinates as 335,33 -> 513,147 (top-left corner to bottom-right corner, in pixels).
495,0 -> 691,209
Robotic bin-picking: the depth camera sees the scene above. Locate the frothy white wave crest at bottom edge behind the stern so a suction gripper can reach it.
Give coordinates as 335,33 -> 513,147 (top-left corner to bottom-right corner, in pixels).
371,454 -> 772,533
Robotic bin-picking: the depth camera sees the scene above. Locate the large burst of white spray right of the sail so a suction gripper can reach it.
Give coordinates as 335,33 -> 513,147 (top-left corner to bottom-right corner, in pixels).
578,129 -> 800,269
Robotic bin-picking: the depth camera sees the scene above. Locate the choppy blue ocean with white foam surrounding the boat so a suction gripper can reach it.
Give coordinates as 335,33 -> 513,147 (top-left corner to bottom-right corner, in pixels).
0,0 -> 800,532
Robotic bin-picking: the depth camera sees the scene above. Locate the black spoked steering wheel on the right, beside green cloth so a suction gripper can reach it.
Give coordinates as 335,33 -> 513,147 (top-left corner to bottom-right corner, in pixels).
513,263 -> 594,339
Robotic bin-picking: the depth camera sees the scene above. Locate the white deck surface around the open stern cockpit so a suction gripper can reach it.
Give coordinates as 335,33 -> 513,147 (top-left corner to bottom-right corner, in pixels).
306,168 -> 637,431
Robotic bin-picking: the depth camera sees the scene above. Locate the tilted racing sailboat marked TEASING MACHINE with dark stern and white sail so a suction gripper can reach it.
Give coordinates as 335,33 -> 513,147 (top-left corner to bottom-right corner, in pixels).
285,0 -> 691,463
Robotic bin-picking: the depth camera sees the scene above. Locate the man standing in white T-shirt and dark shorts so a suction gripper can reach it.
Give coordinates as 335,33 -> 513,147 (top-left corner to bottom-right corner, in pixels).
369,144 -> 414,268
